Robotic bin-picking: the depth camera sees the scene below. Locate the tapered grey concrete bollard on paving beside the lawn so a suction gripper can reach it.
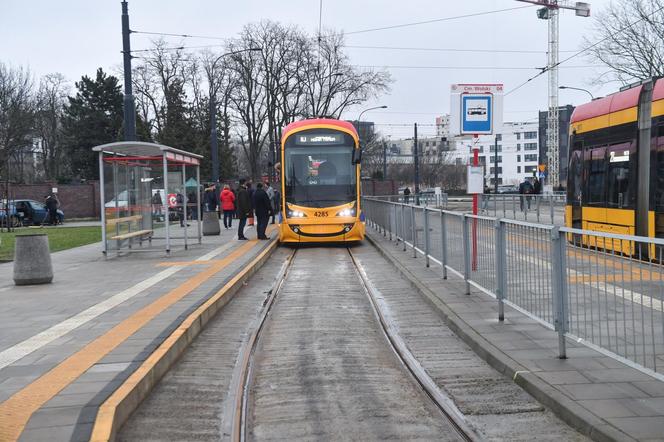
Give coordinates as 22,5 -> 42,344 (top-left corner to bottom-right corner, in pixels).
14,233 -> 53,285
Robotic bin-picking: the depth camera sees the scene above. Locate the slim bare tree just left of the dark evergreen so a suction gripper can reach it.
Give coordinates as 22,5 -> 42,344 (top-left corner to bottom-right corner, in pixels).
35,73 -> 69,180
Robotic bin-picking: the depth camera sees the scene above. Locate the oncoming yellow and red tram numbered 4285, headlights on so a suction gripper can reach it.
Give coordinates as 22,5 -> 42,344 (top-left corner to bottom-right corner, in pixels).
279,118 -> 365,243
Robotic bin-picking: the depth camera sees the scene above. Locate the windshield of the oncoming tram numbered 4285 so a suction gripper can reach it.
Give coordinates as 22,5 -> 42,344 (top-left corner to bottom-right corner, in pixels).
284,129 -> 357,207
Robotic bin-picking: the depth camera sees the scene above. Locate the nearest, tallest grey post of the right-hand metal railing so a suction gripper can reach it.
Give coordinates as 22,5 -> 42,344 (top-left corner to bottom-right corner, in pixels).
551,227 -> 569,359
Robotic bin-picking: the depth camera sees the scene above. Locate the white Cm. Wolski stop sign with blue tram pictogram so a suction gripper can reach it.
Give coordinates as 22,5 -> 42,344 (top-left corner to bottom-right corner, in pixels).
450,84 -> 503,135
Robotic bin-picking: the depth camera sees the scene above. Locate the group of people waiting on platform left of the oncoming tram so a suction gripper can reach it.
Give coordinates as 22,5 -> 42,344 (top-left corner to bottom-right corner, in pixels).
203,179 -> 279,241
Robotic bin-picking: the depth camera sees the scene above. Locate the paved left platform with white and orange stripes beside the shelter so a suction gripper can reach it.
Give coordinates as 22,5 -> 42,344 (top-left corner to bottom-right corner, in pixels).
0,223 -> 276,441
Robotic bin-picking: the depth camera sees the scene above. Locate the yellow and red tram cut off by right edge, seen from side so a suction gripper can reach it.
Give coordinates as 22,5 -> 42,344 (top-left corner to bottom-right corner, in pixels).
565,79 -> 664,255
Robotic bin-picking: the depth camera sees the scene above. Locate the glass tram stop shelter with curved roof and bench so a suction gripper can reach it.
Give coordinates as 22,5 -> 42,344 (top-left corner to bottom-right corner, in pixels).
92,141 -> 203,255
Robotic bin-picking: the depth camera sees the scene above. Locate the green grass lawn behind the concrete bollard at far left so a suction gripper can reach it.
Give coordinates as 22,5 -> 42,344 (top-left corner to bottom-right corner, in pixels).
0,226 -> 101,261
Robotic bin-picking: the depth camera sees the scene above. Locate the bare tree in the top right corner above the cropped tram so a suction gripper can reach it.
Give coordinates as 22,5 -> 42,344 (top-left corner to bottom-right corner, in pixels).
584,0 -> 664,84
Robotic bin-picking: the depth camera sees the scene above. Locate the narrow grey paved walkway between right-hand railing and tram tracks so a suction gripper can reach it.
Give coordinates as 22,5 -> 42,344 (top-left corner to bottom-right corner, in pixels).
367,229 -> 664,441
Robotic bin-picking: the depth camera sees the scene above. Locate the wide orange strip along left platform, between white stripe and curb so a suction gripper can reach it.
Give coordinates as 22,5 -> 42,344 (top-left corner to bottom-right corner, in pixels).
0,241 -> 256,441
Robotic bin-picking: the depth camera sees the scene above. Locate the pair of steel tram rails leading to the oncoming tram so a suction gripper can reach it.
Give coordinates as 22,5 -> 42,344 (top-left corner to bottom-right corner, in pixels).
232,248 -> 481,441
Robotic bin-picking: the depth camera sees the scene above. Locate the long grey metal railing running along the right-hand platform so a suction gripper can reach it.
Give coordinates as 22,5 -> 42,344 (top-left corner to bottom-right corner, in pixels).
363,197 -> 664,380
